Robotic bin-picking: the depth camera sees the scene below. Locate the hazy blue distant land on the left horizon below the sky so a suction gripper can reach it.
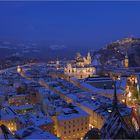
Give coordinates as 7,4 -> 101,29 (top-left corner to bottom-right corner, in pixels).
0,40 -> 88,60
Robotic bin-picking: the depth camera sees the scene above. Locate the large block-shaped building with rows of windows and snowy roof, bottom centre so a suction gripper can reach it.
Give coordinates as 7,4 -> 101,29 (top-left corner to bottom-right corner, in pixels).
55,107 -> 89,140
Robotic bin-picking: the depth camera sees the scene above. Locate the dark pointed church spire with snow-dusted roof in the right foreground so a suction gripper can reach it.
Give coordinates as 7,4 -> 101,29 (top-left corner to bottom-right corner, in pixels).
101,80 -> 136,139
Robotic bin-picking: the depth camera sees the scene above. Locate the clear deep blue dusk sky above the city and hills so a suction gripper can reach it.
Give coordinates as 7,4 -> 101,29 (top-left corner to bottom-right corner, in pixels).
0,1 -> 140,49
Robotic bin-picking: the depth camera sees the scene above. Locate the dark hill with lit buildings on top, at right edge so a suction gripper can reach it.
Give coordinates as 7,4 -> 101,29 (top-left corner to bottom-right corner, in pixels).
93,38 -> 140,67
